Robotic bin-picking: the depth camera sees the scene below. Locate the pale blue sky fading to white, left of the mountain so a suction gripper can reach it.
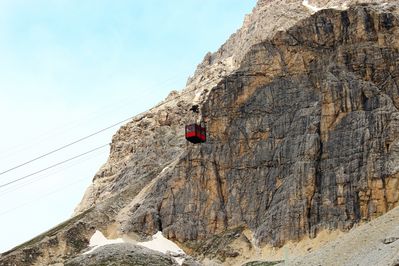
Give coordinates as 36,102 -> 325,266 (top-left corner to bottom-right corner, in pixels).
0,0 -> 256,252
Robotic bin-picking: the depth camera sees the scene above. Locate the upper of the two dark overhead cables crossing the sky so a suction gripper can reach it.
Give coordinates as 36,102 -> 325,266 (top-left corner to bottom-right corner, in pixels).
0,77 -> 219,177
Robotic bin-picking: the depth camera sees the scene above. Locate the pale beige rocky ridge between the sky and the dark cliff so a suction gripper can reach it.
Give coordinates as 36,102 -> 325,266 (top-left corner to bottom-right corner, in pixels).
76,0 -> 316,213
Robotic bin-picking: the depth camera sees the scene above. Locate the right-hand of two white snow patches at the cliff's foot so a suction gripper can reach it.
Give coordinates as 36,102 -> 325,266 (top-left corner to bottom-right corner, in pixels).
137,231 -> 186,265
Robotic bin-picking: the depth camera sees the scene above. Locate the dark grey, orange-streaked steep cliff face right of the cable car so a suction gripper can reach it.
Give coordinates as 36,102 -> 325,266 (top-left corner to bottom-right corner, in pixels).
124,2 -> 399,246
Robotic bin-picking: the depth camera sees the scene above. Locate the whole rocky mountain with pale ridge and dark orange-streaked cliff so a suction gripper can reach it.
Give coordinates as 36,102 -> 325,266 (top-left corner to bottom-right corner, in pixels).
0,0 -> 399,265
